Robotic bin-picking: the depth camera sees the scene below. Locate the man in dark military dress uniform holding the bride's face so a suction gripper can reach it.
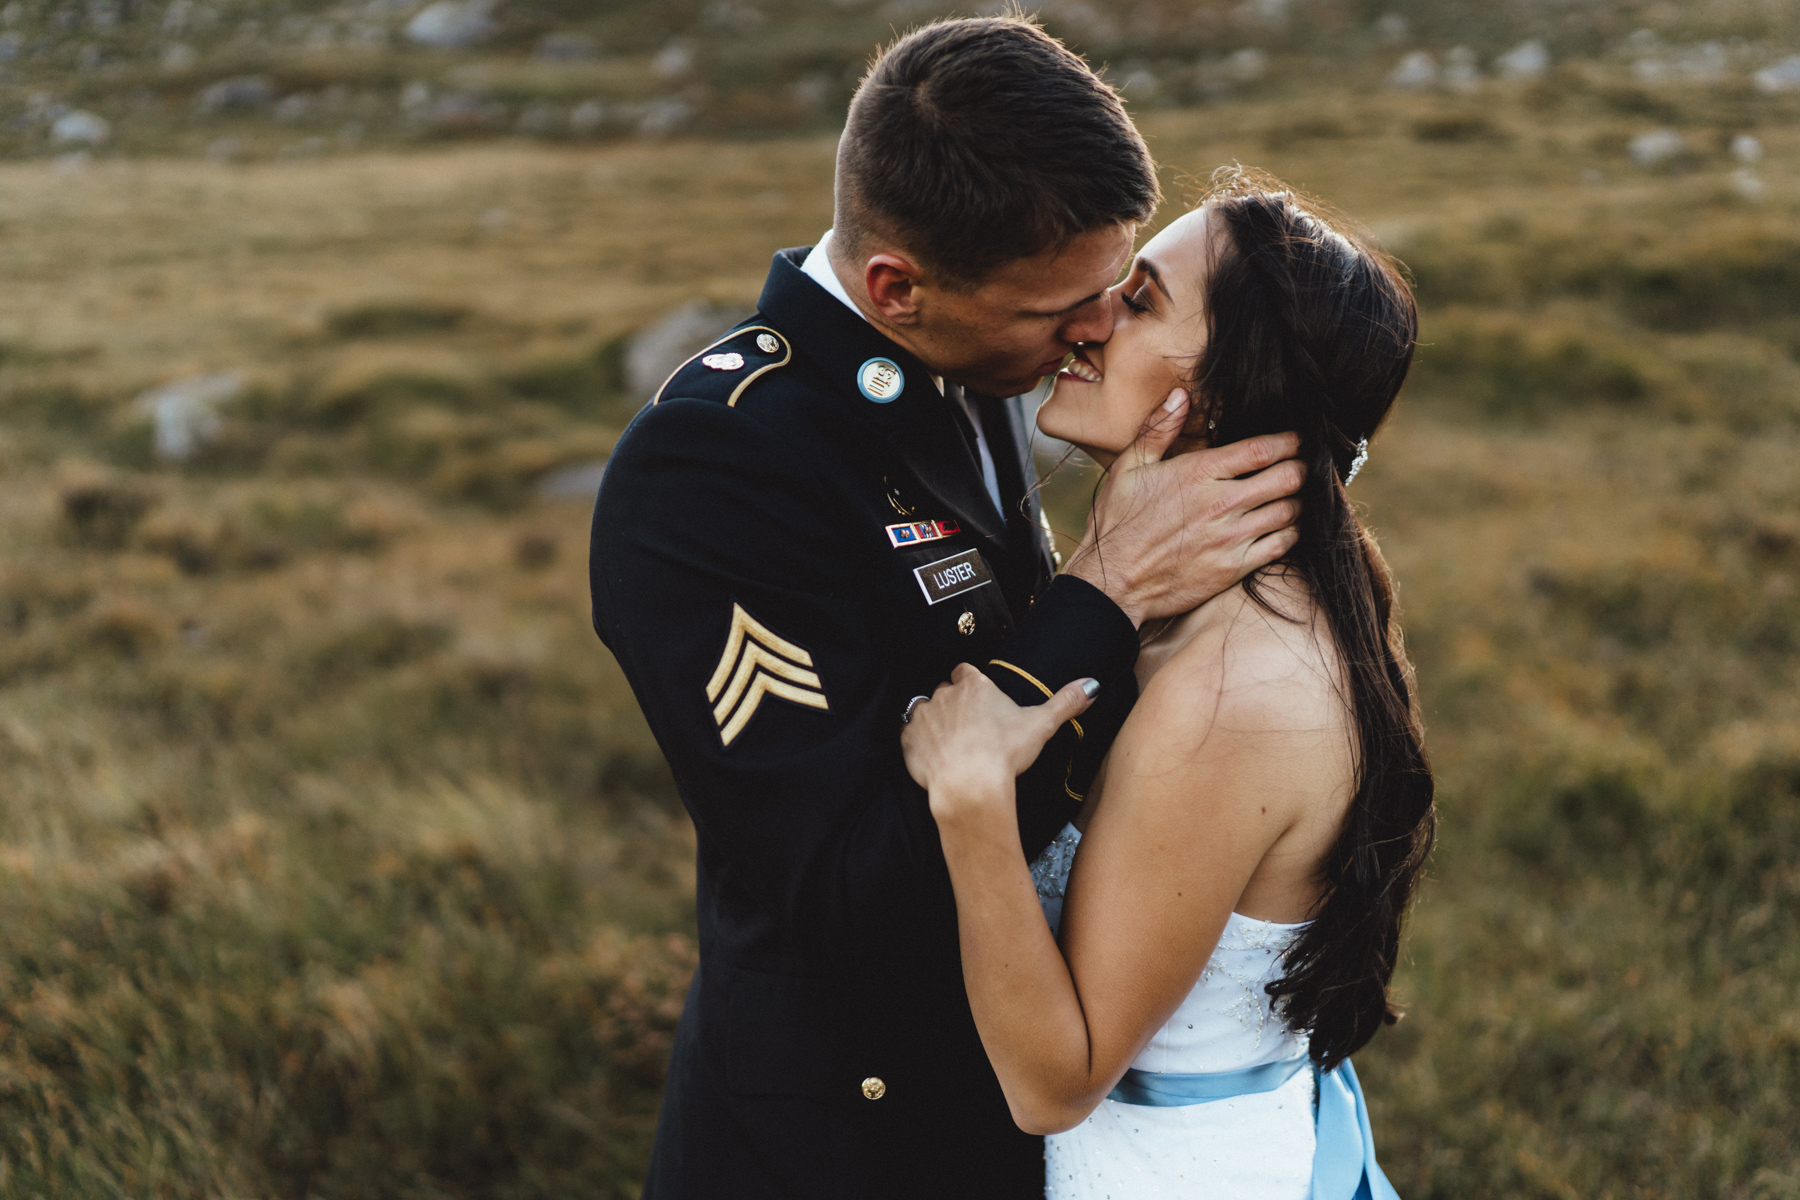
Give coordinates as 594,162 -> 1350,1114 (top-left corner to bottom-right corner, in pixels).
590,18 -> 1300,1200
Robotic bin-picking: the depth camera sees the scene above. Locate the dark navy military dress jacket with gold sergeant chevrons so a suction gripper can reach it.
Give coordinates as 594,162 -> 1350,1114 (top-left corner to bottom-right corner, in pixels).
590,250 -> 1138,1200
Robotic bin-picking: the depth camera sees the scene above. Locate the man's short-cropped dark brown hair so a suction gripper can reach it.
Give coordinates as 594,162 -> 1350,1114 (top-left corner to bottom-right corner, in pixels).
833,16 -> 1161,288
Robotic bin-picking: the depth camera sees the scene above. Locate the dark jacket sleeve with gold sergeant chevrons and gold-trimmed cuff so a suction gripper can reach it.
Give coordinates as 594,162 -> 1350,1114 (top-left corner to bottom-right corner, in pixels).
589,399 -> 1138,957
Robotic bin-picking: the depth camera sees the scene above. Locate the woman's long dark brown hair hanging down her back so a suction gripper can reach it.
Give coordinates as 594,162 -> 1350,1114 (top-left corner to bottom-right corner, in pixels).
1190,169 -> 1436,1070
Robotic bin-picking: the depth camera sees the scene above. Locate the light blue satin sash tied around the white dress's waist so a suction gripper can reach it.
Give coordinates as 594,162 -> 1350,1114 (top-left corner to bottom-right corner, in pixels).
1107,1054 -> 1400,1200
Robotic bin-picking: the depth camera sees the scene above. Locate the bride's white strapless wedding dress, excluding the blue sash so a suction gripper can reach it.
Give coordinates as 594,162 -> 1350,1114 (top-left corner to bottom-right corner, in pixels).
1031,826 -> 1316,1200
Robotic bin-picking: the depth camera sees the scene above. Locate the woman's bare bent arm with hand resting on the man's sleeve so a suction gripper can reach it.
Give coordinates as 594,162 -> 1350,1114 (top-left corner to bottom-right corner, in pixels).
905,626 -> 1348,1132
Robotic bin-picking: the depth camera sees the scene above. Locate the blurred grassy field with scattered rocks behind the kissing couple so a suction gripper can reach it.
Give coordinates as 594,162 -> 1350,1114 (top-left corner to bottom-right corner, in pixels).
0,0 -> 1800,1200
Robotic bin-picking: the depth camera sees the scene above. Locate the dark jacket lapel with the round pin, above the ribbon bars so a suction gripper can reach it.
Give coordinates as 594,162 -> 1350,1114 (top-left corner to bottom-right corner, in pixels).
758,250 -> 1006,551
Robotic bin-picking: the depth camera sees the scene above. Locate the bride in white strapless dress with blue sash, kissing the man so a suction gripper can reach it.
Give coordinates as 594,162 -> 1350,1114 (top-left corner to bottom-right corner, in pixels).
904,171 -> 1435,1200
